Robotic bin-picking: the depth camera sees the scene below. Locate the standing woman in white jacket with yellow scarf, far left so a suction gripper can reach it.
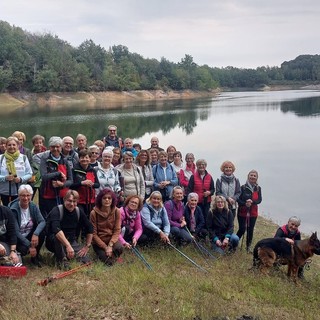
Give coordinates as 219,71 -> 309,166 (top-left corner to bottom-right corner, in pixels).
0,137 -> 32,206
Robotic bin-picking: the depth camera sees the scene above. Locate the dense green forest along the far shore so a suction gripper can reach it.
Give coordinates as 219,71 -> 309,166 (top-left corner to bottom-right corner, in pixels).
0,20 -> 320,92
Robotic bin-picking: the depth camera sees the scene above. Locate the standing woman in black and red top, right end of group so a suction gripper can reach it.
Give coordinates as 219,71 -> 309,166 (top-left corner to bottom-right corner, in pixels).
237,170 -> 262,253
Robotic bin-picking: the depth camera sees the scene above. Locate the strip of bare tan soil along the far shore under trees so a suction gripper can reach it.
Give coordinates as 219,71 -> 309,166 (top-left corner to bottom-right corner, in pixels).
0,90 -> 219,109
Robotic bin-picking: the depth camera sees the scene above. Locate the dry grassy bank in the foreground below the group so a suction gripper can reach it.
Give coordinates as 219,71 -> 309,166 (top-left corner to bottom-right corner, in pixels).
0,218 -> 320,320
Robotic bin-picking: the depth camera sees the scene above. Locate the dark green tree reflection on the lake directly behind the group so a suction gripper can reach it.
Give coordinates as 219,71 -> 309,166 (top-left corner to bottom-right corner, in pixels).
1,100 -> 210,146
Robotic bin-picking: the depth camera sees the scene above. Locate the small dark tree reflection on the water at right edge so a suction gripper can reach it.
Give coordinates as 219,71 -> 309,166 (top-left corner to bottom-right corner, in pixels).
281,97 -> 320,117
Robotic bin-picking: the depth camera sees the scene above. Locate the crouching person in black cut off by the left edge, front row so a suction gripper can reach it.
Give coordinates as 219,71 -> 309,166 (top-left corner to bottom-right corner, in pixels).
0,205 -> 21,264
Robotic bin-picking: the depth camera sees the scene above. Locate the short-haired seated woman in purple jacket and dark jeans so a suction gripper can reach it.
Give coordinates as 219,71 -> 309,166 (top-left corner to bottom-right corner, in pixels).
164,186 -> 192,245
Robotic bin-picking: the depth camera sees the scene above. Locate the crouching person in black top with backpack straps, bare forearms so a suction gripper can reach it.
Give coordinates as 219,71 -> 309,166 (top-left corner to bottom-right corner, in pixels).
46,190 -> 93,269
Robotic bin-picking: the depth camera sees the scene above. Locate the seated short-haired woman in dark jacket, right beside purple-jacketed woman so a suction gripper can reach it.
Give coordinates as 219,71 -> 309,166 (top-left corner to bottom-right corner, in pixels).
184,192 -> 208,239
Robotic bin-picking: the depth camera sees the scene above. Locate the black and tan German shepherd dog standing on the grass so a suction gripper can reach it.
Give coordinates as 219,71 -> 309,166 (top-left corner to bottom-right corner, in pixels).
253,232 -> 320,282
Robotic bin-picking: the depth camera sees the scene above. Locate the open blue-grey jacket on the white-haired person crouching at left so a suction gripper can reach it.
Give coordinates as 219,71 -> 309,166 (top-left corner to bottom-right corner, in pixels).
9,198 -> 46,247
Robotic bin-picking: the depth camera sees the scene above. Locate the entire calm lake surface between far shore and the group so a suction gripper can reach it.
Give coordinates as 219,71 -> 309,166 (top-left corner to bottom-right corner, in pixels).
0,90 -> 320,233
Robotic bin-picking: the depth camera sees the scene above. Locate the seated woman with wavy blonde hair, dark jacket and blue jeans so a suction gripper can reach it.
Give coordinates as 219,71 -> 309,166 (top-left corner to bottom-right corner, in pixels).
207,196 -> 239,254
